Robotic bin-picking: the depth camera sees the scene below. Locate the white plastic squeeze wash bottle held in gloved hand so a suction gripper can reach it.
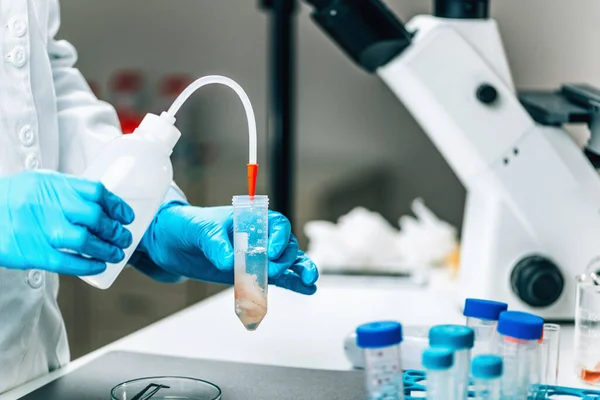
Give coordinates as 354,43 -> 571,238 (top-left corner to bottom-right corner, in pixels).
81,112 -> 181,289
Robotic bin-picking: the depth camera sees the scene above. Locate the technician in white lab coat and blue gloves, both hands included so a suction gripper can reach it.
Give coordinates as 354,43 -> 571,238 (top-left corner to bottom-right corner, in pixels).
0,0 -> 318,393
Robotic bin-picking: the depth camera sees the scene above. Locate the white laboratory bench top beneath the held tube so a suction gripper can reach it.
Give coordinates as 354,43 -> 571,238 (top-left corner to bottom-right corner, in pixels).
0,272 -> 596,400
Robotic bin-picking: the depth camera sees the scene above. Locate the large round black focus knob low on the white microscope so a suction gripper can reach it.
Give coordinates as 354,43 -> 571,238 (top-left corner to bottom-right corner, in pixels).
510,256 -> 565,307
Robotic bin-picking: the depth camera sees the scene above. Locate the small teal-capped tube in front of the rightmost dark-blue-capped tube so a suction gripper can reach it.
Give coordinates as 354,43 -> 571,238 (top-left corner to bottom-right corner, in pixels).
471,354 -> 503,400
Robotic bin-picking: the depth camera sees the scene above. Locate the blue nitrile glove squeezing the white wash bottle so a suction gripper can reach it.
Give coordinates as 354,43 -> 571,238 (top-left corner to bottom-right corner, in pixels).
0,171 -> 134,275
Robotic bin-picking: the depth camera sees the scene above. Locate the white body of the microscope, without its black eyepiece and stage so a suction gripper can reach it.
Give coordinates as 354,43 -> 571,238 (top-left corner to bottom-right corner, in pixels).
377,16 -> 600,320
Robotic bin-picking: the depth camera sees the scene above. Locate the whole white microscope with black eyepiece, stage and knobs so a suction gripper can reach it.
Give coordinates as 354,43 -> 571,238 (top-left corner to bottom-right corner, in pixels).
305,0 -> 600,321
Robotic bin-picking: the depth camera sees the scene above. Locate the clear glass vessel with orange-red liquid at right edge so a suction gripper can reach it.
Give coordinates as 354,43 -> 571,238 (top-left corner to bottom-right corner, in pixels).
575,273 -> 600,385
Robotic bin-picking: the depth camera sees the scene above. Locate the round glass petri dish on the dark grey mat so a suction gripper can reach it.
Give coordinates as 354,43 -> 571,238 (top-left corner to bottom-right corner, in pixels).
110,376 -> 221,400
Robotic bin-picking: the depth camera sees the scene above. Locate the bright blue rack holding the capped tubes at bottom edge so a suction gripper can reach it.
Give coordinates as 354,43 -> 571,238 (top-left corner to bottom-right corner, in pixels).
404,370 -> 600,400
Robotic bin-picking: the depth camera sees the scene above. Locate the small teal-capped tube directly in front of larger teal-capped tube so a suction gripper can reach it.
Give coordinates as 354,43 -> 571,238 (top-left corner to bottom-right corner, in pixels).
422,347 -> 454,400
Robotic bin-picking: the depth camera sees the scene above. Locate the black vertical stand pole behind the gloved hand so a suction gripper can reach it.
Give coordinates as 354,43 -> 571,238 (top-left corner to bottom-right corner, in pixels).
261,0 -> 296,226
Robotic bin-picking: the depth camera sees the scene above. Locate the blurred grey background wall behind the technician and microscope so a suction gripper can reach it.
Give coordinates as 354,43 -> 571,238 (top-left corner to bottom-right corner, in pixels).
59,0 -> 600,356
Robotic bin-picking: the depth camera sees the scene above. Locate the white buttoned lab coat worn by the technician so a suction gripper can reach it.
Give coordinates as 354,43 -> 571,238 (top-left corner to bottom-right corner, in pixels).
0,0 -> 134,393
